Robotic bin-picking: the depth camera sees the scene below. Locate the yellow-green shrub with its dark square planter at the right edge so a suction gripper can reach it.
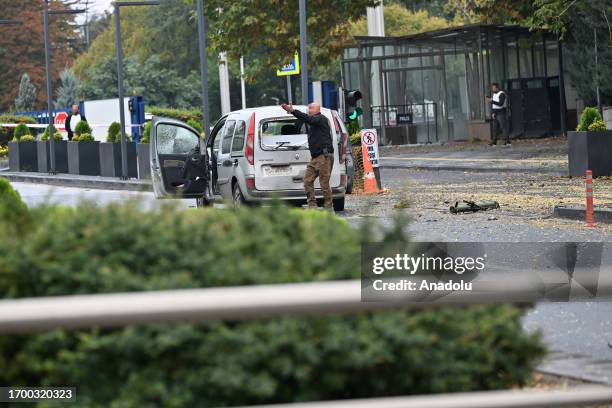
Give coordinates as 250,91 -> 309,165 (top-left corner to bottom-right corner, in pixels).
567,107 -> 612,177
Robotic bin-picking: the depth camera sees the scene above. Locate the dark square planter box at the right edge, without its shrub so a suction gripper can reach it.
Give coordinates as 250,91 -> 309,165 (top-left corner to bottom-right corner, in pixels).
567,130 -> 612,177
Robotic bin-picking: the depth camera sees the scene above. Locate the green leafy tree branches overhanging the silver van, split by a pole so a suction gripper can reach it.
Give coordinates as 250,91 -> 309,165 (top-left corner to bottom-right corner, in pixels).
201,0 -> 378,81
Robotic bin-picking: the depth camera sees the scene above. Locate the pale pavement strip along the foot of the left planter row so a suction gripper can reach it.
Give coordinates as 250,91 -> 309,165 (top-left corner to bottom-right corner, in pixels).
0,169 -> 153,191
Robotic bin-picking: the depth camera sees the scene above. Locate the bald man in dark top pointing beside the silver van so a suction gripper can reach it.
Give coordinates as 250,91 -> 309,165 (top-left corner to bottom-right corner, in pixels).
281,102 -> 334,211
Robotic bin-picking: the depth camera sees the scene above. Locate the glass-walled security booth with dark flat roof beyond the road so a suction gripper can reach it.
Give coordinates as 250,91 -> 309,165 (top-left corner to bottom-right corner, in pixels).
342,24 -> 575,144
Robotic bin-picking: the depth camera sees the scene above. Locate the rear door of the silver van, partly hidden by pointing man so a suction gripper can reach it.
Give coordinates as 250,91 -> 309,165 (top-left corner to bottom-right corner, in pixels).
255,111 -> 340,191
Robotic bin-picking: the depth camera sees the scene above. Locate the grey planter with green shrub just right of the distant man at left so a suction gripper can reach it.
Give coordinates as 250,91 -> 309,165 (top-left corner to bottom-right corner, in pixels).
68,125 -> 100,176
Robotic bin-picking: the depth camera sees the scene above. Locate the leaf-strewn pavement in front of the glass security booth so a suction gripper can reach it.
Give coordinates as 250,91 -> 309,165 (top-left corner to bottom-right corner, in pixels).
380,138 -> 568,176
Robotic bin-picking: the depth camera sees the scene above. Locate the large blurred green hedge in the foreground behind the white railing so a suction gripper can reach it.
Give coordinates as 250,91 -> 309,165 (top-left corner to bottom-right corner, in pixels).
0,186 -> 543,407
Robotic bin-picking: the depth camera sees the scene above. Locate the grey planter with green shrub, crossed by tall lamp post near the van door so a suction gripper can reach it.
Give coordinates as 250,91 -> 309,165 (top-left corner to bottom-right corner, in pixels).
100,122 -> 138,178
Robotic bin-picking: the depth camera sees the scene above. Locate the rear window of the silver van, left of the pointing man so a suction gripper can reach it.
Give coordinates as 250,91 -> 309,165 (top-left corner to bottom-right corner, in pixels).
259,118 -> 308,150
